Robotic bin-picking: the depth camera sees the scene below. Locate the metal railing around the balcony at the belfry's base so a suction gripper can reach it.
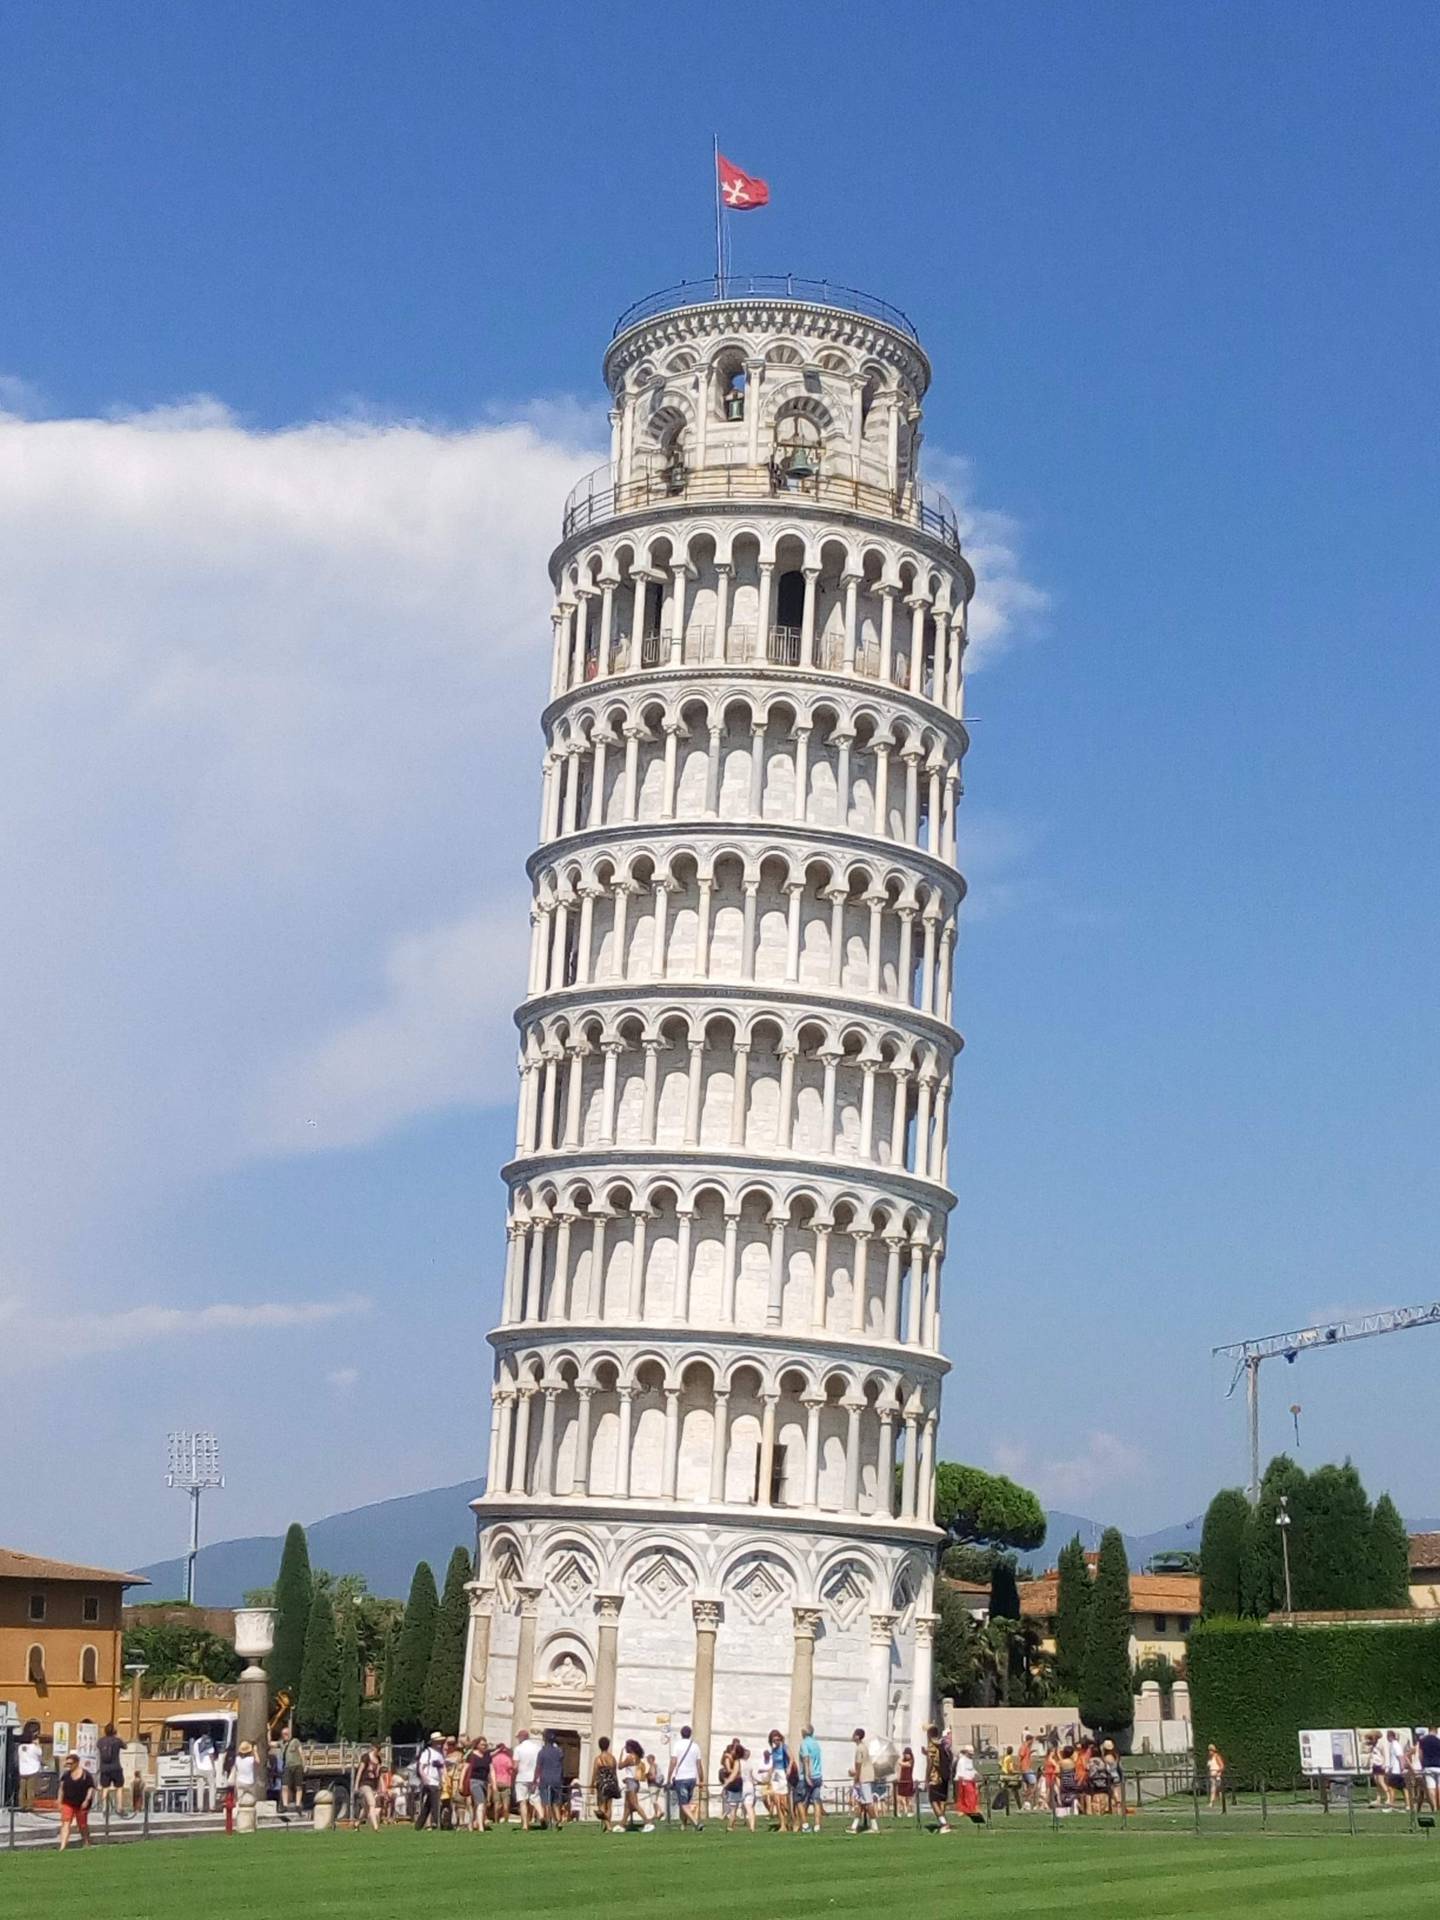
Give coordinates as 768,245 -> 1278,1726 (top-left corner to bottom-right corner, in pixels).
561,461 -> 960,553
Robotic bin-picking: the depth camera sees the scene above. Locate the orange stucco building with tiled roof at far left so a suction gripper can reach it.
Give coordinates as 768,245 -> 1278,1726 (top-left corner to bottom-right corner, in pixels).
0,1548 -> 146,1743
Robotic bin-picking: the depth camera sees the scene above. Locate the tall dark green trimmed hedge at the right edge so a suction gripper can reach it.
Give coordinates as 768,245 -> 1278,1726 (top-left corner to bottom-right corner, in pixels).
1187,1620 -> 1440,1788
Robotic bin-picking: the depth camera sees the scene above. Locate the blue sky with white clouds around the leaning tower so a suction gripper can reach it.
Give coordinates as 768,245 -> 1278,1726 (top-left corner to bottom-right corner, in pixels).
0,0 -> 1440,1561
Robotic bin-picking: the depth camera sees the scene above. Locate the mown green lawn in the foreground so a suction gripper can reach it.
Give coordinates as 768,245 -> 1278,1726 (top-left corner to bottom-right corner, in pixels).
0,1820 -> 1440,1920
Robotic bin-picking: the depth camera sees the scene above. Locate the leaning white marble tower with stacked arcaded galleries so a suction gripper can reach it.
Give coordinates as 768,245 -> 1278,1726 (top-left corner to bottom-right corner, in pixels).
463,278 -> 973,1780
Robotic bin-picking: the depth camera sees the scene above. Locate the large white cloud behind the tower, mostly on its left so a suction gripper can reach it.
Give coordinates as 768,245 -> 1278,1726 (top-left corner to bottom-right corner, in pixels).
0,380 -> 1039,1311
